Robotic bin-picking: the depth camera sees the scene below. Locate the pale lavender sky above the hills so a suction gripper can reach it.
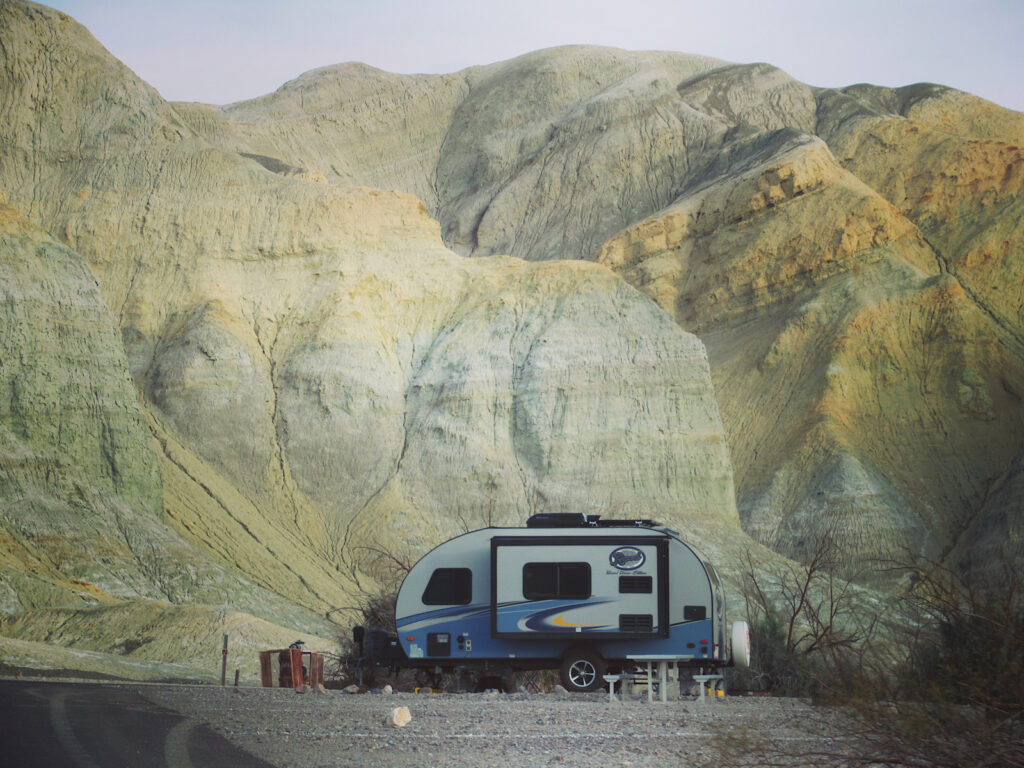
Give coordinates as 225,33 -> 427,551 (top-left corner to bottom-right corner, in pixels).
47,0 -> 1024,111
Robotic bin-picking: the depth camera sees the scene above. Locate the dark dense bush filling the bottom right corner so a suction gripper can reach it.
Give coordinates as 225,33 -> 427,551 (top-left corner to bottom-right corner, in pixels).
857,562 -> 1024,768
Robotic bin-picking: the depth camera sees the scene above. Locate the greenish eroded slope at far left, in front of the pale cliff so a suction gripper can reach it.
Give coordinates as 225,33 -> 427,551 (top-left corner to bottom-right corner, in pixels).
0,195 -> 348,632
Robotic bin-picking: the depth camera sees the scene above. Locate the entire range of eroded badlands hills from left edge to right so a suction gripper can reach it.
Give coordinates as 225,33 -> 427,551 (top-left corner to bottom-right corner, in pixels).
0,0 -> 1024,676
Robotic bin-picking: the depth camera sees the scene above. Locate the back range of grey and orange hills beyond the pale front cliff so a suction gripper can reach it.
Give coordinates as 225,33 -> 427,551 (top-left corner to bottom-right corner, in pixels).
197,46 -> 1024,577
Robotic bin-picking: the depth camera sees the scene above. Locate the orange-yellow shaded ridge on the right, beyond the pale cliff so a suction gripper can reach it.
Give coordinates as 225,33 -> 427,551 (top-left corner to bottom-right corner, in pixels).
598,89 -> 1024,577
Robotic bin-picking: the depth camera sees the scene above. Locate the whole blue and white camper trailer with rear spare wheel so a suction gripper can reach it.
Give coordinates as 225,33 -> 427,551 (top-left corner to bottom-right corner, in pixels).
387,514 -> 750,691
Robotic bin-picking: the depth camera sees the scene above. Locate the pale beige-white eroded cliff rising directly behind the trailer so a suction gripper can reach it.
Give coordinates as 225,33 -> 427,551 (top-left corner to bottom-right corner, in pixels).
0,2 -> 744,660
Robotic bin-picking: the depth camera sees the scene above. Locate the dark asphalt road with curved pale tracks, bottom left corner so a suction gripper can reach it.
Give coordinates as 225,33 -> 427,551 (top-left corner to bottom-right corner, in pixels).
0,681 -> 270,768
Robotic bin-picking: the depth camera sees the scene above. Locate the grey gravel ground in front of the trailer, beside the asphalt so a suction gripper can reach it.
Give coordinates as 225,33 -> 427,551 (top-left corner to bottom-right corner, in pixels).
145,686 -> 834,768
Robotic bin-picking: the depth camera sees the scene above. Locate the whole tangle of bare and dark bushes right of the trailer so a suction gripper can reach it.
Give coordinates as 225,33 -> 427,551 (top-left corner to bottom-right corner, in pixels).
718,548 -> 1024,768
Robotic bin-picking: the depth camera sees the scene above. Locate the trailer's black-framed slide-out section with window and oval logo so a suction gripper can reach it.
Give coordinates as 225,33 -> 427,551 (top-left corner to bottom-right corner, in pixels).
490,536 -> 669,640
